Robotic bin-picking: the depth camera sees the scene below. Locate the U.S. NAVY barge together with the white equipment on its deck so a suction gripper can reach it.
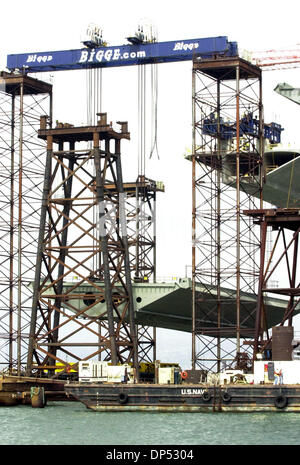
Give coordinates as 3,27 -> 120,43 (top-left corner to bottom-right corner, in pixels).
65,360 -> 300,412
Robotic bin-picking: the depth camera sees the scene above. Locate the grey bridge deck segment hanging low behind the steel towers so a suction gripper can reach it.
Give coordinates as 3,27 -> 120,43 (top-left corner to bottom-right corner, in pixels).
57,278 -> 300,338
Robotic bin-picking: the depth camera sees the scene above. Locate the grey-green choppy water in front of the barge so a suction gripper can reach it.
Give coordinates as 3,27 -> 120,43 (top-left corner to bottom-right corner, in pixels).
0,402 -> 300,446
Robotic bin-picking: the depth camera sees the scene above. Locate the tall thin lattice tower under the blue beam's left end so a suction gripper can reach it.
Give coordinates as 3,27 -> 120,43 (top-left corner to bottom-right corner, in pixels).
0,72 -> 52,373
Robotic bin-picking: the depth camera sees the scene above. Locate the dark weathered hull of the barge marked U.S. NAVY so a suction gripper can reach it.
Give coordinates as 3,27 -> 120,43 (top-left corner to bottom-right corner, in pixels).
65,383 -> 300,413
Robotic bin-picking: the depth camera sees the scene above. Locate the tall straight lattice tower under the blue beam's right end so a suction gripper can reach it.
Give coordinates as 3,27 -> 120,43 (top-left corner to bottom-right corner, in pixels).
192,57 -> 264,371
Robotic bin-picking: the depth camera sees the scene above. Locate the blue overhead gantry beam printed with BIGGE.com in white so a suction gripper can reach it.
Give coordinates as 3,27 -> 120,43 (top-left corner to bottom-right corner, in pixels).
7,36 -> 238,73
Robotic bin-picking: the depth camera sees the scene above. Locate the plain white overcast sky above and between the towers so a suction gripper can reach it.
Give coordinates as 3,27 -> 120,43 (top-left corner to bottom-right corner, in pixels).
0,0 -> 300,370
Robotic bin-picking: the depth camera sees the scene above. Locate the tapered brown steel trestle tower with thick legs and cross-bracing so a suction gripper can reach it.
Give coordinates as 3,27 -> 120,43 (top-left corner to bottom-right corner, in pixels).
27,113 -> 138,373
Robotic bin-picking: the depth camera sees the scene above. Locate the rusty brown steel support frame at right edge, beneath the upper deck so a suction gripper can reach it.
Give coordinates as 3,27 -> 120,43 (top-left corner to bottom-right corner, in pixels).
245,208 -> 300,359
